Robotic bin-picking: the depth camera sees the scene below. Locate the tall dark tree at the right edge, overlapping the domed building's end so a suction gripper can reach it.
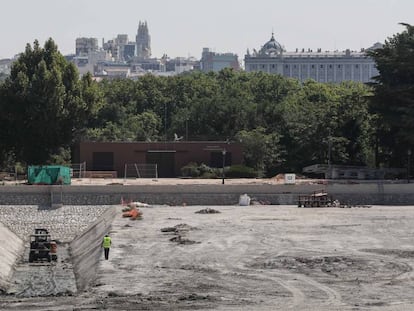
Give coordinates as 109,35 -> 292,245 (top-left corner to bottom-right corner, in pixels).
368,24 -> 414,166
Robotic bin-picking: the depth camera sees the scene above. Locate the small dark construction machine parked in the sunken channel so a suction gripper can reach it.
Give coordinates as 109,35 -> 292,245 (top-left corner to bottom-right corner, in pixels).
29,229 -> 57,262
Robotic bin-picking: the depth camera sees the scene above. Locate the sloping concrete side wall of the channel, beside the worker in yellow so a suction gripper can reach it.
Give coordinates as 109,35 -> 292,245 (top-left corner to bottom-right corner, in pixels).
70,207 -> 116,291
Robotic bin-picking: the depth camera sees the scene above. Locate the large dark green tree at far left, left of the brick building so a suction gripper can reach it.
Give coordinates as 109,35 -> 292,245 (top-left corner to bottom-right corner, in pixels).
0,39 -> 97,164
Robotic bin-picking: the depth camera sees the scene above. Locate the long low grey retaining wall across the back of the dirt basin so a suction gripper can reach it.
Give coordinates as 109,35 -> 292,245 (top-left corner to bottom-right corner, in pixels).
0,183 -> 414,205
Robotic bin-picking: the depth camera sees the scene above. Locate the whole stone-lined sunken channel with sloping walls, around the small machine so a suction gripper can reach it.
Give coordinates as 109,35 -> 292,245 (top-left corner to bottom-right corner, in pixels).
0,205 -> 115,297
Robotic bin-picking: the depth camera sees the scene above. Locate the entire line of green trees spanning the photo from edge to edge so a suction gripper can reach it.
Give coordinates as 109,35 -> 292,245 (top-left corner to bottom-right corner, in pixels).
0,24 -> 414,176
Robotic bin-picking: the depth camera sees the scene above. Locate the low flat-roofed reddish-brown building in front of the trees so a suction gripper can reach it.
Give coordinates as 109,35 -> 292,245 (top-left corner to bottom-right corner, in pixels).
75,141 -> 243,178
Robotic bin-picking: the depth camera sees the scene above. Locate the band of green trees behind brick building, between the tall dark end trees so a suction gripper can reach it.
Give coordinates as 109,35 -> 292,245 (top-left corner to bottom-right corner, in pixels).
89,69 -> 373,175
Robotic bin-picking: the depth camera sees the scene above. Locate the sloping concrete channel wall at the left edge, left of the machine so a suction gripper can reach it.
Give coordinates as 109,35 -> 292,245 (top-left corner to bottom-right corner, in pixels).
0,223 -> 24,291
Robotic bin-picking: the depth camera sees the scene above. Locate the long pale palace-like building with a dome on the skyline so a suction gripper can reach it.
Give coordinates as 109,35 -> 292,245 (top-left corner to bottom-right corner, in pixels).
244,33 -> 382,83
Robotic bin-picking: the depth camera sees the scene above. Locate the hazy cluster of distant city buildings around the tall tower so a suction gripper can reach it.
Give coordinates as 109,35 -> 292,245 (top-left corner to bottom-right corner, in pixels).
70,21 -> 240,79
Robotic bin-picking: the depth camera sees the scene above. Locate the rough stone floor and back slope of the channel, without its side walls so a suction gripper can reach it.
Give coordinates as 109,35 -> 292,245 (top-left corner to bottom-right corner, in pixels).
0,206 -> 108,297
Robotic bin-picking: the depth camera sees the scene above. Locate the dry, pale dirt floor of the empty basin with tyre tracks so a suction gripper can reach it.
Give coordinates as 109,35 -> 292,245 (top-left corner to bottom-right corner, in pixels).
0,206 -> 414,311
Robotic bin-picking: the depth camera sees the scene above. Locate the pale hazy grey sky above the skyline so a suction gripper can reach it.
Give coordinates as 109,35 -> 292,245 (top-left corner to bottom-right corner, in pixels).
0,0 -> 414,59
